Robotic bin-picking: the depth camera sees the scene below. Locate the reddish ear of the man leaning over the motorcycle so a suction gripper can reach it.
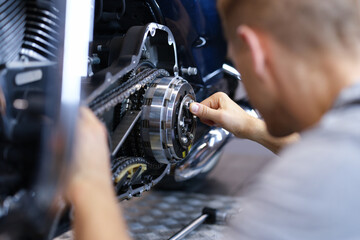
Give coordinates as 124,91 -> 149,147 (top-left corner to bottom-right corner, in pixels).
237,25 -> 266,77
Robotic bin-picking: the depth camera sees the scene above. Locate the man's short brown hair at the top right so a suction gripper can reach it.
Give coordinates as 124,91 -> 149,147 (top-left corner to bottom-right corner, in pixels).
218,0 -> 360,52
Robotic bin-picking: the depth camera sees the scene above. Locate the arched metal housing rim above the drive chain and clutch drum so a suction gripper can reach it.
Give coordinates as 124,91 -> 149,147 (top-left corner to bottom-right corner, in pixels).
86,23 -> 179,104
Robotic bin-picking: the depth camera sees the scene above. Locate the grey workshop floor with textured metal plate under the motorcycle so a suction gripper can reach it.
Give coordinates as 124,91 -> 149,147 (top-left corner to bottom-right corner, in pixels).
56,139 -> 274,240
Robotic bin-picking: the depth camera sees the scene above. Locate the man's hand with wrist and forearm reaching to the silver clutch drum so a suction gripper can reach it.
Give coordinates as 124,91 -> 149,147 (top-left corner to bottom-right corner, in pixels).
190,93 -> 299,154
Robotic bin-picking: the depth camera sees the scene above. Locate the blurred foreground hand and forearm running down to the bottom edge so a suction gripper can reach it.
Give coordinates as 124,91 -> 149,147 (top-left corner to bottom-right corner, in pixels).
65,108 -> 130,240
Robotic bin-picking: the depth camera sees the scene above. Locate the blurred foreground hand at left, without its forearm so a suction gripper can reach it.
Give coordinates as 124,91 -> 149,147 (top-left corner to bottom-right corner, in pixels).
66,108 -> 112,201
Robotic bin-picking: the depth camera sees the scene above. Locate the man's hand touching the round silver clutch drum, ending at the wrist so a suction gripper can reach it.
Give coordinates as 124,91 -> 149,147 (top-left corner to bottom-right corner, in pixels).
190,92 -> 260,138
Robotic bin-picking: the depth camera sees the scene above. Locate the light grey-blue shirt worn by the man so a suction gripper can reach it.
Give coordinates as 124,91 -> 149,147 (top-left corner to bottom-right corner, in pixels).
228,83 -> 360,240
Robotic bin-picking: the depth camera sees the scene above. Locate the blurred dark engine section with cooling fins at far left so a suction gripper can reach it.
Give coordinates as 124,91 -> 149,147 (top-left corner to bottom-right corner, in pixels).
0,0 -> 59,202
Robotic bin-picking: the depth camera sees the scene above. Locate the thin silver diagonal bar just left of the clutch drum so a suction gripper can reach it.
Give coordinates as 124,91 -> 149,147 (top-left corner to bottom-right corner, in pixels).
111,111 -> 142,157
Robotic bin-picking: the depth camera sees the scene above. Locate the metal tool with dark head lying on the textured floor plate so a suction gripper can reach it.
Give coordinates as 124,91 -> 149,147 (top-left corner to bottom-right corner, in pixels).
169,207 -> 228,240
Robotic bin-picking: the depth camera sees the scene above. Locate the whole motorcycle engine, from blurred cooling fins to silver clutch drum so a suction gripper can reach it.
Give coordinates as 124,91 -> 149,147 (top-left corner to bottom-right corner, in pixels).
0,0 -> 196,210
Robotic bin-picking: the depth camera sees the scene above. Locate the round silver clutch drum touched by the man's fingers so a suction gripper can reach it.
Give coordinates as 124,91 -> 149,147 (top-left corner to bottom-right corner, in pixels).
142,77 -> 196,164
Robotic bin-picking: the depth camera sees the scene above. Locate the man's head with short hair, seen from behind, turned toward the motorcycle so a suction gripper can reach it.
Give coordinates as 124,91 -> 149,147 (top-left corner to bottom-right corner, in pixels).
218,0 -> 360,136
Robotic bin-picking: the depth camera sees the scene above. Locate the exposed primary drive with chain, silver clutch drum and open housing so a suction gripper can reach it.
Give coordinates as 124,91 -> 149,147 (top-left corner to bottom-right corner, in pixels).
84,20 -> 196,198
